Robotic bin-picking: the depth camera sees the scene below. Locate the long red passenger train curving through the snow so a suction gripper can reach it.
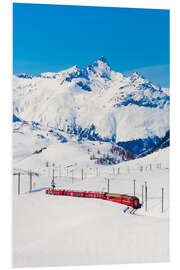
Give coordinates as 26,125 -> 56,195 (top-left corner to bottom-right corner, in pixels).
46,189 -> 141,209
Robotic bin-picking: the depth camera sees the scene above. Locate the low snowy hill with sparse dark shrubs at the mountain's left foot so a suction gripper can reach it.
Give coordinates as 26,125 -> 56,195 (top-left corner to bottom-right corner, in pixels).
13,116 -> 136,169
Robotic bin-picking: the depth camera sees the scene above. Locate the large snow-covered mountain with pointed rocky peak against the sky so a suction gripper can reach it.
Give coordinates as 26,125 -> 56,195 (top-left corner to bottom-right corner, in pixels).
13,57 -> 169,154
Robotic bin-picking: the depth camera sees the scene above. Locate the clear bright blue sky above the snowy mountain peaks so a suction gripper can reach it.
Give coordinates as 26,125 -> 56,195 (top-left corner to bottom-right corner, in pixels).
13,3 -> 169,87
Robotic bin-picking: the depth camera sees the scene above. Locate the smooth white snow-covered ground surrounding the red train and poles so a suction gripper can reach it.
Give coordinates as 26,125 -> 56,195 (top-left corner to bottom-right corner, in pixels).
13,141 -> 169,267
